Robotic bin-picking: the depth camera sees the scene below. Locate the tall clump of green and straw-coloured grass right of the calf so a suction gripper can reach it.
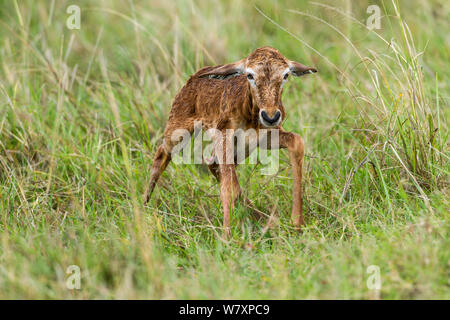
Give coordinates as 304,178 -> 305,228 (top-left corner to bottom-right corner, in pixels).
284,1 -> 448,210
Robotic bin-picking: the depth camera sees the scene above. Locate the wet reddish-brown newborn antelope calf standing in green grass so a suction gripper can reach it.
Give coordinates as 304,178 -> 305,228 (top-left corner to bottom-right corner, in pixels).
144,47 -> 317,235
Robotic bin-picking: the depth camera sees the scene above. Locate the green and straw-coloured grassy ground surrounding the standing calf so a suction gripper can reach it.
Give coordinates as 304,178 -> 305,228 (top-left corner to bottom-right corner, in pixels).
0,0 -> 450,299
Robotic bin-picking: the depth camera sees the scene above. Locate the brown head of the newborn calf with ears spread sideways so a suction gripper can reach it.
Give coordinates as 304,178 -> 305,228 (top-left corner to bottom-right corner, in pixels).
201,47 -> 317,128
